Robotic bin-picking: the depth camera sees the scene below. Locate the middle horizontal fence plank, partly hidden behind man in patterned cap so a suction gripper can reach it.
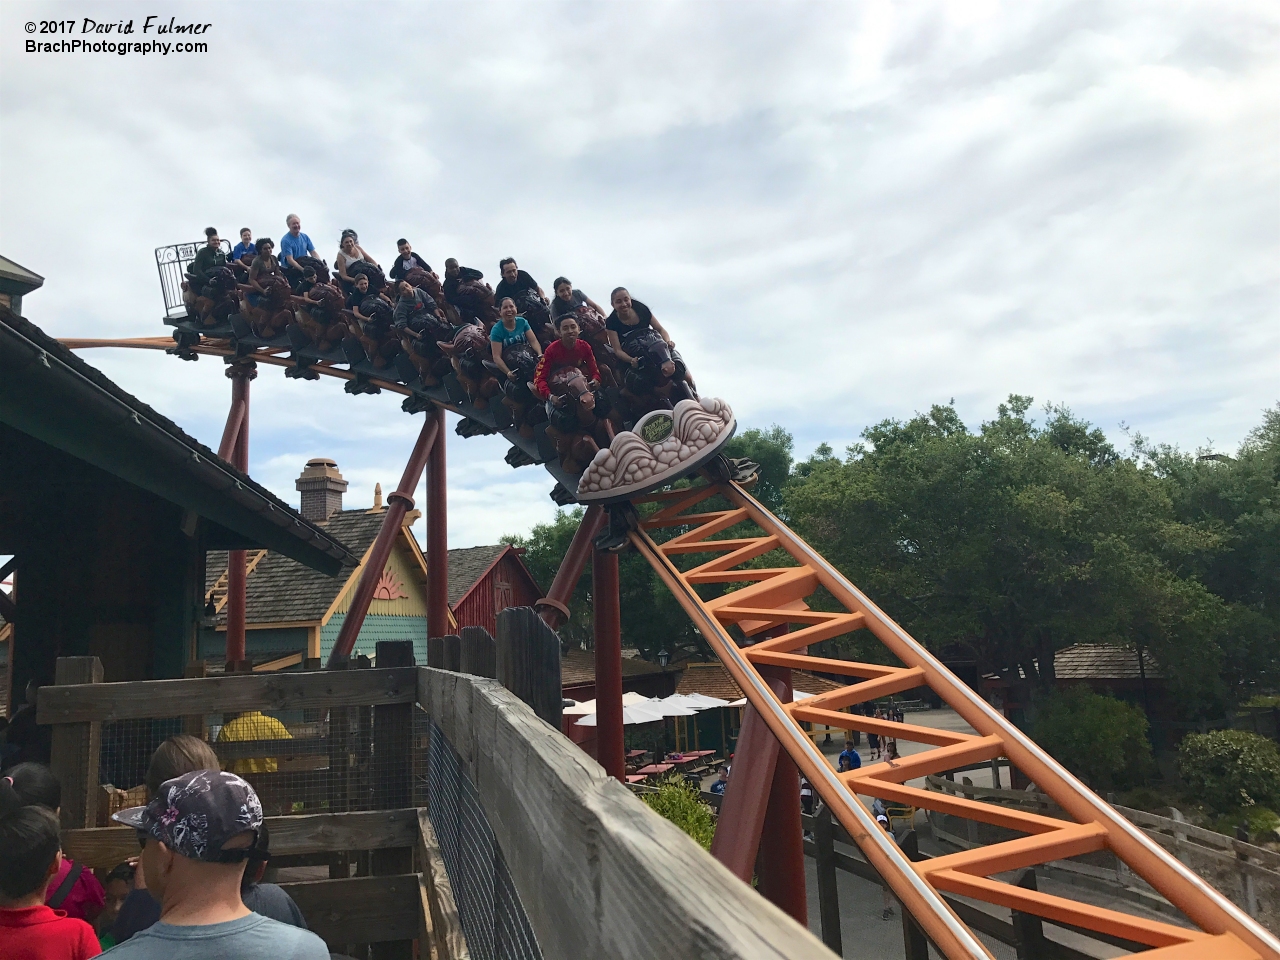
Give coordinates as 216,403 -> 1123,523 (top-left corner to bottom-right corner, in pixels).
63,809 -> 419,869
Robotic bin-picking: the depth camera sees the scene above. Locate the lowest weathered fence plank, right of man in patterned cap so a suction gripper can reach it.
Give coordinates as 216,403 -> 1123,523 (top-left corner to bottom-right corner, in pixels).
280,873 -> 422,950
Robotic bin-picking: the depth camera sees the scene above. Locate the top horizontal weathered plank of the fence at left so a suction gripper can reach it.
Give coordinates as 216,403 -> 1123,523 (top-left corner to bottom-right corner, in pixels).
36,667 -> 417,723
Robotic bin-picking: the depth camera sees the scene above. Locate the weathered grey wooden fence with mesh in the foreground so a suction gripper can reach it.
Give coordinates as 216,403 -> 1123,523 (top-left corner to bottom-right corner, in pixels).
37,654 -> 831,960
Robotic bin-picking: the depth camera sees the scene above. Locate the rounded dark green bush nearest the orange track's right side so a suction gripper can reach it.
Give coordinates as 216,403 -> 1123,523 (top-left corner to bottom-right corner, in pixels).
1032,686 -> 1151,788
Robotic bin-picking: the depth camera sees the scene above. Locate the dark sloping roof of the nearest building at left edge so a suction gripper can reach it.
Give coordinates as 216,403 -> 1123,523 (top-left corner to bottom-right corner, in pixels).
0,307 -> 358,576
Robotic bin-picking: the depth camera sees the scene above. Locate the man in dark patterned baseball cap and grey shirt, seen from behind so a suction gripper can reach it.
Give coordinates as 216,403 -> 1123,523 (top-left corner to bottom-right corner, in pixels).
108,771 -> 329,960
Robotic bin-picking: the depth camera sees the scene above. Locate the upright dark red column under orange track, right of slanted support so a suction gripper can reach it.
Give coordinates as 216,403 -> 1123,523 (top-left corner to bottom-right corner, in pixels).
752,667 -> 809,927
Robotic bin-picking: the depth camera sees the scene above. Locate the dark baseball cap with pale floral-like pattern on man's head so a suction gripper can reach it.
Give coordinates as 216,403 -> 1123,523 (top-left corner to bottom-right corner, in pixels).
111,771 -> 262,863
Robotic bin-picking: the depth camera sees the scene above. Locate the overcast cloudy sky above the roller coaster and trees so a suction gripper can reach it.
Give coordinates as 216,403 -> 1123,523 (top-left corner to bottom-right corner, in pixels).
0,0 -> 1280,547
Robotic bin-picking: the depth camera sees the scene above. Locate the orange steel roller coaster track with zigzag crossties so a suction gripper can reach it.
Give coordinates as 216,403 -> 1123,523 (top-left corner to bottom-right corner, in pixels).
61,337 -> 1280,960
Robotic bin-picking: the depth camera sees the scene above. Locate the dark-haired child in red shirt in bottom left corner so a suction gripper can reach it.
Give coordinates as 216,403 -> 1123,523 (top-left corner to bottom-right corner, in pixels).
0,777 -> 101,960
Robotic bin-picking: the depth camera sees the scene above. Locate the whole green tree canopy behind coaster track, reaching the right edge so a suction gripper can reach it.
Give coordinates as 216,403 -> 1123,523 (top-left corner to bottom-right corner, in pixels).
506,396 -> 1280,716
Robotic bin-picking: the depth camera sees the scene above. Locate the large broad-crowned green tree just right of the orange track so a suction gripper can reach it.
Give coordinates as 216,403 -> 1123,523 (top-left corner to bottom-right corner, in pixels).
783,396 -> 1222,709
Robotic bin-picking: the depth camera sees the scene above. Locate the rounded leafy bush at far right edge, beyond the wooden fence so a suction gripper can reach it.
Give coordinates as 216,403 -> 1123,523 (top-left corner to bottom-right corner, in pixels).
1178,730 -> 1280,813
